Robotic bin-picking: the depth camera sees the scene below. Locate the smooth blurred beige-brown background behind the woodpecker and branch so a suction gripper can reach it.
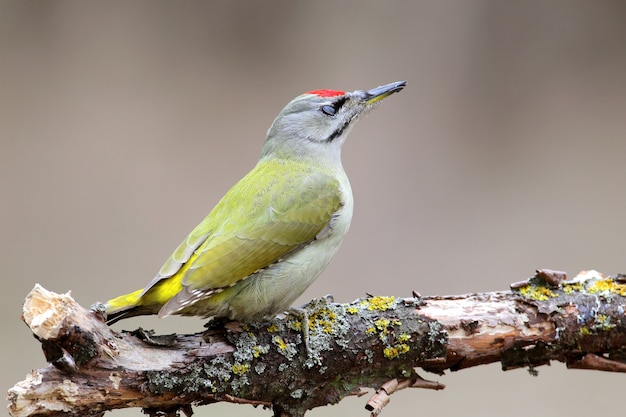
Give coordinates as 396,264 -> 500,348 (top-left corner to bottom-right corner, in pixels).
0,0 -> 626,417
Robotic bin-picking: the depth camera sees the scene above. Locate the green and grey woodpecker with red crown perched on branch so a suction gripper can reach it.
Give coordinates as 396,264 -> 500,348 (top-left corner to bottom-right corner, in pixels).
104,81 -> 406,324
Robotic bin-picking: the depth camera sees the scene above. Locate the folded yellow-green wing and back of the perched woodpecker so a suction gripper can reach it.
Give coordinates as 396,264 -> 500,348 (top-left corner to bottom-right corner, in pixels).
144,161 -> 343,315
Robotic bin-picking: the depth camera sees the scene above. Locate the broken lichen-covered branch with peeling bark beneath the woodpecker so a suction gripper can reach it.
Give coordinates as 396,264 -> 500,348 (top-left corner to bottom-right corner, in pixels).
9,271 -> 626,417
